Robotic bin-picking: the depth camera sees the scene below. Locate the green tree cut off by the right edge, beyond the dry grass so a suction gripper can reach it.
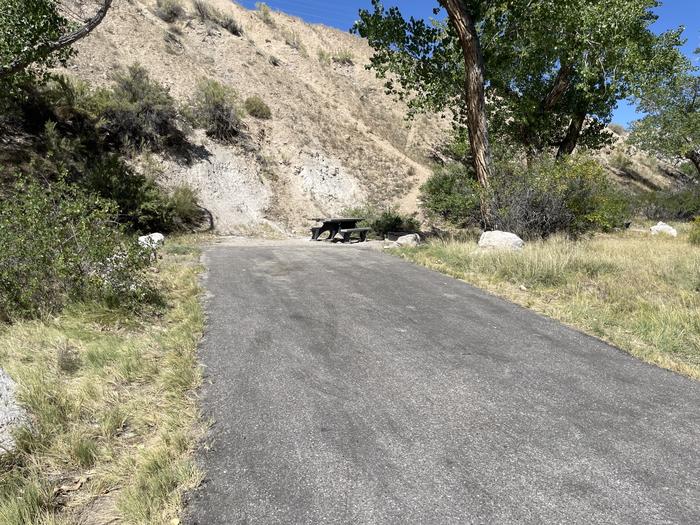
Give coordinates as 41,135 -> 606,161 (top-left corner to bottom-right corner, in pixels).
630,54 -> 700,176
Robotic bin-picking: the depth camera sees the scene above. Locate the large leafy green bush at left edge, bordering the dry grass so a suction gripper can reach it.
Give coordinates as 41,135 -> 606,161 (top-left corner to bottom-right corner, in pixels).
0,182 -> 155,321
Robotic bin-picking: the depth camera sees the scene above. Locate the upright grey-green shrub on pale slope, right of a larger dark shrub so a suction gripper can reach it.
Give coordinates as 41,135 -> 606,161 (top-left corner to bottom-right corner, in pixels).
191,79 -> 243,142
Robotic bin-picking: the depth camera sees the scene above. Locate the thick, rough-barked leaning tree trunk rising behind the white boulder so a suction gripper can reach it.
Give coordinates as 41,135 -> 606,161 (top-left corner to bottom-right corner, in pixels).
442,0 -> 493,228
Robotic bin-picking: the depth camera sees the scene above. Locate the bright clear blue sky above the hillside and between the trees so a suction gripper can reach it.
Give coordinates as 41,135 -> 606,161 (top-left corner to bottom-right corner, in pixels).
237,0 -> 700,125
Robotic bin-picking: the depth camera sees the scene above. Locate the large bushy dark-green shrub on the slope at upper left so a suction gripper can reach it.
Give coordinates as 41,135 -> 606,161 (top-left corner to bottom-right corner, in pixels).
89,64 -> 186,151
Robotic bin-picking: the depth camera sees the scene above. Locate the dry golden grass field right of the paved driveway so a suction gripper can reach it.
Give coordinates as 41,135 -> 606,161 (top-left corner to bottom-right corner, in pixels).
398,225 -> 700,379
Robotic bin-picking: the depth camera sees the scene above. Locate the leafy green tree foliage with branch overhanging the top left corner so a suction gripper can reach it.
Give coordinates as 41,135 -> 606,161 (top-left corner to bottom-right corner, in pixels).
0,0 -> 112,86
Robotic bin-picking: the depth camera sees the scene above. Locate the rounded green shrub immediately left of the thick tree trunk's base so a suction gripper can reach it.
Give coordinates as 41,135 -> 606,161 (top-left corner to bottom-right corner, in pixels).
419,164 -> 481,228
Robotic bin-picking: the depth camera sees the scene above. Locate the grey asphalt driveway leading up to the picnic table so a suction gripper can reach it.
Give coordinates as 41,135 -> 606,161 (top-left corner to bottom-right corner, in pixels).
188,239 -> 700,525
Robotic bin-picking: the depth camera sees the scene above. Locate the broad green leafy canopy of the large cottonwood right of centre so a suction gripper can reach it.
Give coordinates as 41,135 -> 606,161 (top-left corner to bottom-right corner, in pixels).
354,0 -> 682,168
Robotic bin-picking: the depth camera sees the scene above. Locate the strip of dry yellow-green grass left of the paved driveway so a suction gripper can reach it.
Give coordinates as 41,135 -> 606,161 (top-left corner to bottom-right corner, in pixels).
0,239 -> 204,525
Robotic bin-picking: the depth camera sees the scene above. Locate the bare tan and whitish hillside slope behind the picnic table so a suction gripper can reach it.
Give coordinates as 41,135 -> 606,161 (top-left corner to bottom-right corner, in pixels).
58,0 -> 446,232
